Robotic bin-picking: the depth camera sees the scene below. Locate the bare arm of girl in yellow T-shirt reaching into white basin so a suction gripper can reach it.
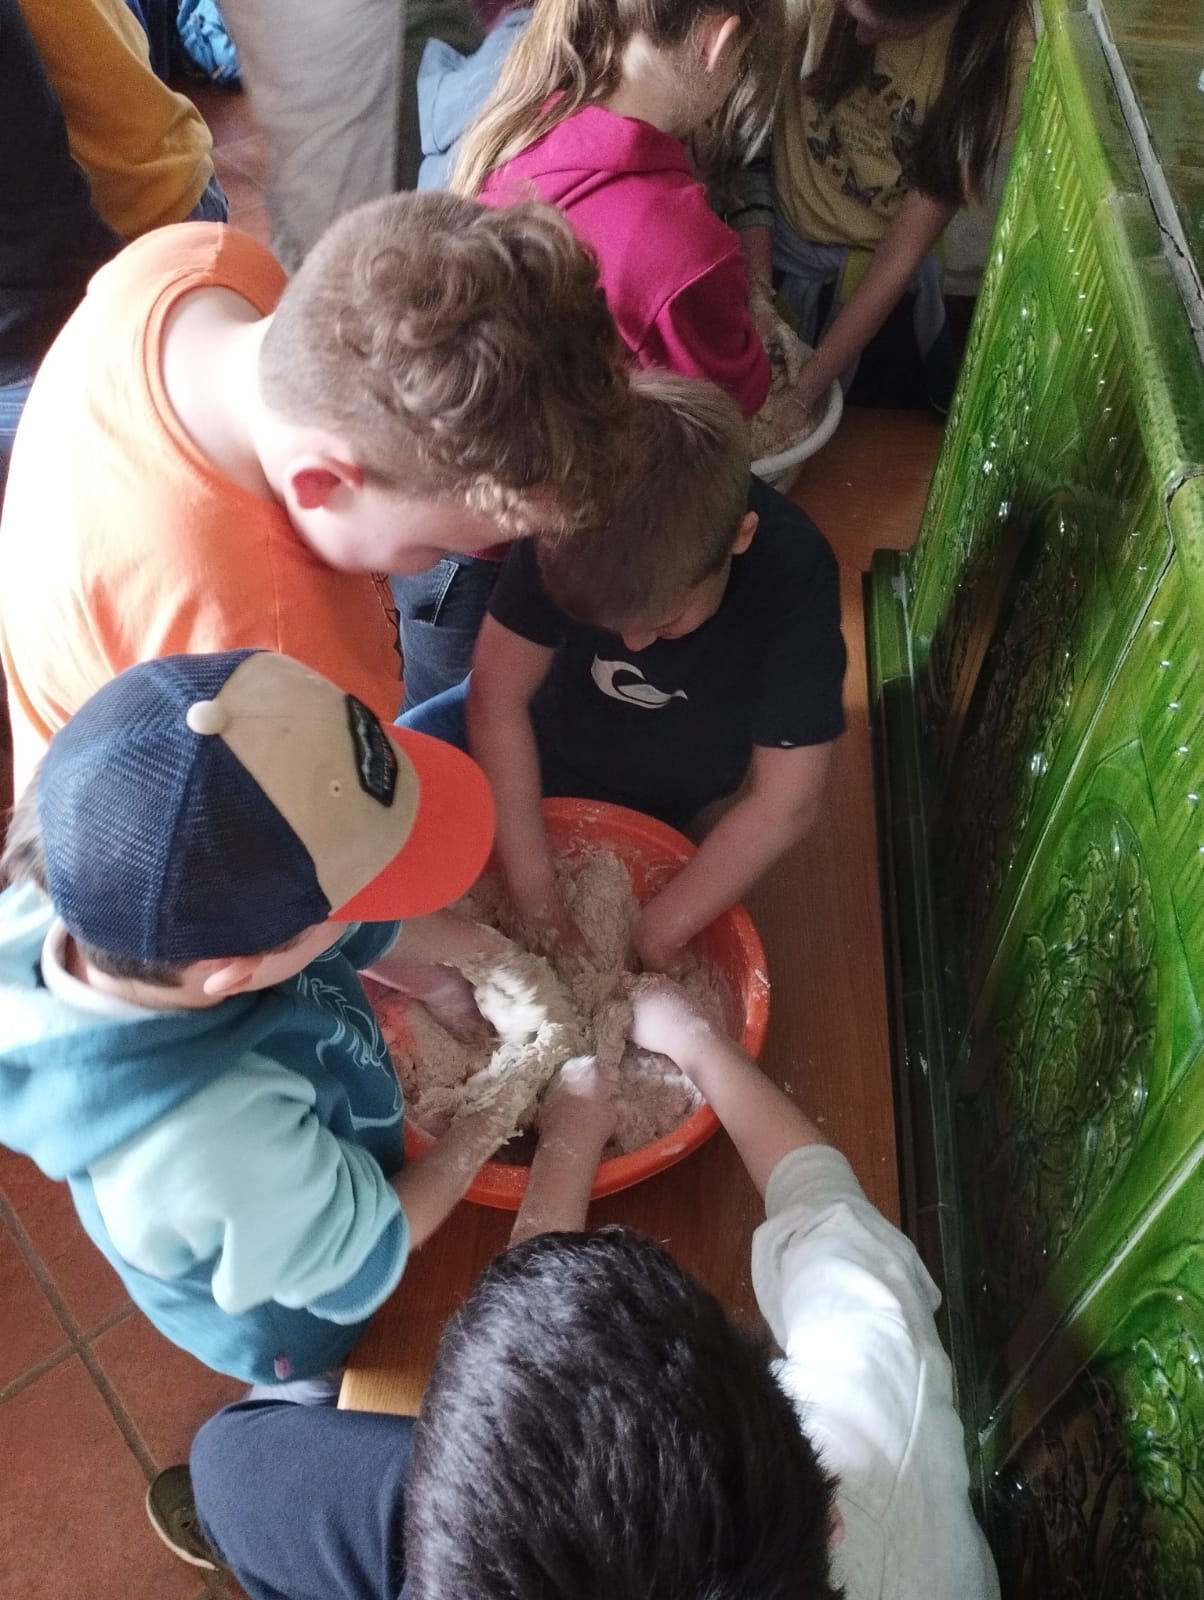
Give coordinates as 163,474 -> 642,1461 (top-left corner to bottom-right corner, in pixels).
790,189 -> 957,408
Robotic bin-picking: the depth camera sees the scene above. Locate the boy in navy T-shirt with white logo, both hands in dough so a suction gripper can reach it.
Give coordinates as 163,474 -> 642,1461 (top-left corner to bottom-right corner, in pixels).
405,374 -> 845,968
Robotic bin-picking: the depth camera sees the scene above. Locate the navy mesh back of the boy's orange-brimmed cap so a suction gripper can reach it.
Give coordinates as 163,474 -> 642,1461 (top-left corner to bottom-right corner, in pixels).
38,650 -> 330,962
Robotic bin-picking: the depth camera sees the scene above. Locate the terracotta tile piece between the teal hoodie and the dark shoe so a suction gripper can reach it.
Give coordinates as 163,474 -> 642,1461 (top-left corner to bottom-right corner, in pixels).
91,1312 -> 247,1467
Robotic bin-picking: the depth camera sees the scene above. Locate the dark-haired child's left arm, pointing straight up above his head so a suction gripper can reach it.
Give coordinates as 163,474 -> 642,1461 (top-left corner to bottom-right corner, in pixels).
511,1056 -> 616,1245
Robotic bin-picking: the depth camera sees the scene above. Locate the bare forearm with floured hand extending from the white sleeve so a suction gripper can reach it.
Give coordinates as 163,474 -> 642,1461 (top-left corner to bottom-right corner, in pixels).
631,978 -> 828,1195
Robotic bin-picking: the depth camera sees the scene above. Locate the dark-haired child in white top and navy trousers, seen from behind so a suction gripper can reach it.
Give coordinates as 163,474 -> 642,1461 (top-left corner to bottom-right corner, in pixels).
185,978 -> 999,1600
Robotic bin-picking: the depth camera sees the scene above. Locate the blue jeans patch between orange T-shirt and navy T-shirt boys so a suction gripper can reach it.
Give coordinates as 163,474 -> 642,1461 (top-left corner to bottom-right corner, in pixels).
391,555 -> 501,712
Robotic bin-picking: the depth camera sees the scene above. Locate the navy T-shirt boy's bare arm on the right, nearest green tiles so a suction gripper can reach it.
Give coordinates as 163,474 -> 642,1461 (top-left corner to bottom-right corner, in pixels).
632,744 -> 833,970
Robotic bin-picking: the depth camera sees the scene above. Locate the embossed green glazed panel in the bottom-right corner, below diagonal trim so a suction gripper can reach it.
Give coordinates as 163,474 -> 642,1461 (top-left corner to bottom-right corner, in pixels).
986,1182 -> 1204,1600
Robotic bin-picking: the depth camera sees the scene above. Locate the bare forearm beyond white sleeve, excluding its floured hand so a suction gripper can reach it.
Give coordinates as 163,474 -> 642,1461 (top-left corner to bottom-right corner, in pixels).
674,1029 -> 828,1195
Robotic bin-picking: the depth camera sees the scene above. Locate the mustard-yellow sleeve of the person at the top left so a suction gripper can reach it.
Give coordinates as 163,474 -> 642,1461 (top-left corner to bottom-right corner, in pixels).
21,0 -> 213,238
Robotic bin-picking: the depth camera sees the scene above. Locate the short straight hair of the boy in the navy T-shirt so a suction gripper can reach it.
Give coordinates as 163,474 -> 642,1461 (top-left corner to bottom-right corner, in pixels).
538,371 -> 751,629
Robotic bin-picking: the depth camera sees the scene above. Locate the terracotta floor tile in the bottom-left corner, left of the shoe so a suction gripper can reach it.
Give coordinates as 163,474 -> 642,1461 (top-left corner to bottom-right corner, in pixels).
0,1357 -> 203,1600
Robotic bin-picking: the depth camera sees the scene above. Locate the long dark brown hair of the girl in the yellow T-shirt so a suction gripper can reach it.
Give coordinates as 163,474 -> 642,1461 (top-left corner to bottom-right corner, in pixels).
799,0 -> 1026,205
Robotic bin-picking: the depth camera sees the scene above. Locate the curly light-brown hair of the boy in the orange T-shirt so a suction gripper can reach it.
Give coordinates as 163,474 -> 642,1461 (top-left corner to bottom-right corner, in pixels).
259,194 -> 631,530
